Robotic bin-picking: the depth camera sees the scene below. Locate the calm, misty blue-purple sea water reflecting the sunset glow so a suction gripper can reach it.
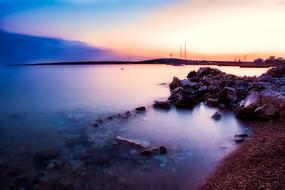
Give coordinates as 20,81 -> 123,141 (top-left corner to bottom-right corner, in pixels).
0,65 -> 267,189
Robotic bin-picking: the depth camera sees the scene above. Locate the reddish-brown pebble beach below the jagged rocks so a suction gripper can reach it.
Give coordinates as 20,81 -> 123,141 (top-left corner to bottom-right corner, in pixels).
200,118 -> 285,190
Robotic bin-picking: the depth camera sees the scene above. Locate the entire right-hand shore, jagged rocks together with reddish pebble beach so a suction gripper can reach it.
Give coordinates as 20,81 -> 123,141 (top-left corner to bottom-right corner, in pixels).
159,66 -> 285,189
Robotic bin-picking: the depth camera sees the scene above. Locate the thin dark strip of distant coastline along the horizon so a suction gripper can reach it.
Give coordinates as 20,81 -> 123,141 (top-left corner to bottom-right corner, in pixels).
9,58 -> 284,68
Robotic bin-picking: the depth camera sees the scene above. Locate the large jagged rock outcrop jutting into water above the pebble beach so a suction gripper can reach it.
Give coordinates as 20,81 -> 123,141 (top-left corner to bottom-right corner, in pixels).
164,66 -> 285,120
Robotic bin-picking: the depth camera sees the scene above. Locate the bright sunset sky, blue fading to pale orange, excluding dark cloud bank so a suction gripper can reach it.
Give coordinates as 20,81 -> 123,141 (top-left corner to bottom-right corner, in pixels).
0,0 -> 285,60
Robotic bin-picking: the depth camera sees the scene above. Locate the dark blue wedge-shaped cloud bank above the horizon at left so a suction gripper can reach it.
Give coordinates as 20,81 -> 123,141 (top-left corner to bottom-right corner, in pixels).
0,29 -> 120,64
